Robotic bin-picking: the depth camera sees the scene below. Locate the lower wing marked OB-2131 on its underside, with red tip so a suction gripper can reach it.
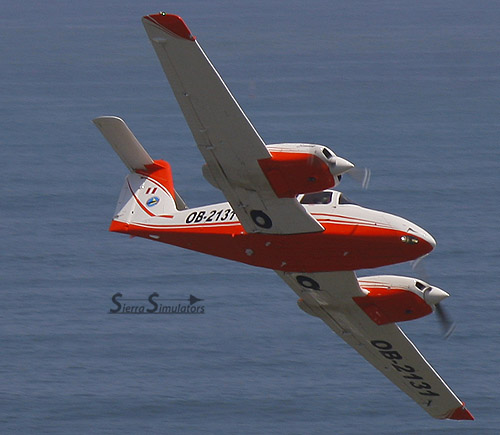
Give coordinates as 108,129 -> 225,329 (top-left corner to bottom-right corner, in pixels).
276,271 -> 473,420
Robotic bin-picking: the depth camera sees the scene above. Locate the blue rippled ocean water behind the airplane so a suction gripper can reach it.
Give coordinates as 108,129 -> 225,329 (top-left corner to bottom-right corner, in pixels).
0,0 -> 500,434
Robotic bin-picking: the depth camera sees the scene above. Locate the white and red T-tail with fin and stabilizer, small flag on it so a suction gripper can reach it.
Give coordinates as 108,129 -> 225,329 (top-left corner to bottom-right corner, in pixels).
94,116 -> 187,232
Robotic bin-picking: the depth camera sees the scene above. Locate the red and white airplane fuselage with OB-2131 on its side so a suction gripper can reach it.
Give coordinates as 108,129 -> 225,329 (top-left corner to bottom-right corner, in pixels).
110,198 -> 435,272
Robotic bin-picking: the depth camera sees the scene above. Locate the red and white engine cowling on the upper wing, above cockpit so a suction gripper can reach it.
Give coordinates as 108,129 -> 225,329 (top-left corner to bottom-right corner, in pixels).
259,143 -> 354,198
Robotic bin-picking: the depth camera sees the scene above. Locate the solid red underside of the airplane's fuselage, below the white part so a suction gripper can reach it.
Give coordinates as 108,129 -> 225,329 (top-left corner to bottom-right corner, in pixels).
110,221 -> 432,272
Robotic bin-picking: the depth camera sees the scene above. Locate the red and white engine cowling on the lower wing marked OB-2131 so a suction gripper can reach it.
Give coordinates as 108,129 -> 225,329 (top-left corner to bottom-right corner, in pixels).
353,275 -> 449,325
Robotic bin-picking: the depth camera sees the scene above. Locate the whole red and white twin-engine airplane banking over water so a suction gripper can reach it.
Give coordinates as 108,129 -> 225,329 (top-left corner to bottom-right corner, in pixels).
94,13 -> 474,420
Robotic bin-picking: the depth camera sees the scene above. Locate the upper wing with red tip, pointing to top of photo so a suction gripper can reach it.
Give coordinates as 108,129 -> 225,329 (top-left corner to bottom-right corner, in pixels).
143,13 -> 324,234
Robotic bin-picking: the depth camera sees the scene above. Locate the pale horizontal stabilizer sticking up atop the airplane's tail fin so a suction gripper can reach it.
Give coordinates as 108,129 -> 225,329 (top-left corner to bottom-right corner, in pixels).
93,116 -> 153,172
